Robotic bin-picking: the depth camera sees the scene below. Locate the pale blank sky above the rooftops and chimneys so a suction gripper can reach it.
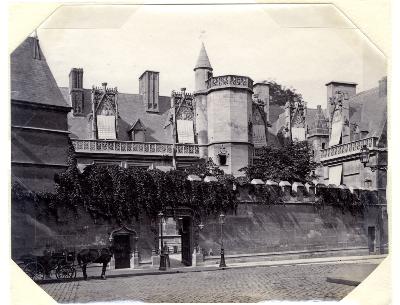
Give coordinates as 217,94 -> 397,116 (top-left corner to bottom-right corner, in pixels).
37,4 -> 386,107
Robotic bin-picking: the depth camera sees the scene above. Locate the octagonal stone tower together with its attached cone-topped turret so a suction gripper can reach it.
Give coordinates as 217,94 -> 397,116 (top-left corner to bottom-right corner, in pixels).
194,44 -> 253,176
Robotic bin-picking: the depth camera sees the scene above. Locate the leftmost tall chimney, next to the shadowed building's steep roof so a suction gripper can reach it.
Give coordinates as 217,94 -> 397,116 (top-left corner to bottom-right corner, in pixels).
69,68 -> 84,115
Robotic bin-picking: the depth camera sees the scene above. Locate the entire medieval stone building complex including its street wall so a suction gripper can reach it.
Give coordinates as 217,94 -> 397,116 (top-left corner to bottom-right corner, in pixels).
11,37 -> 387,268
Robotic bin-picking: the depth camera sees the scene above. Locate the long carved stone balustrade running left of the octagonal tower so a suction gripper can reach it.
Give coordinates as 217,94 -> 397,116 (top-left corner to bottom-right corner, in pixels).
72,139 -> 199,157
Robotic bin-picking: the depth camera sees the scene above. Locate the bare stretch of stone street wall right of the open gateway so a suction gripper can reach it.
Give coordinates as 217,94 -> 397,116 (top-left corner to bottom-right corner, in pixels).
199,203 -> 388,255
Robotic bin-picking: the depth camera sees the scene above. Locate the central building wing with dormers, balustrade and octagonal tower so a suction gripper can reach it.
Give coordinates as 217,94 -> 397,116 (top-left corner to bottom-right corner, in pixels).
66,45 -> 269,175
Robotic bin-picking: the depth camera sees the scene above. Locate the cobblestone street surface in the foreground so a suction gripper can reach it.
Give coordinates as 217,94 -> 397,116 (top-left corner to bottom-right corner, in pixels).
37,263 -> 368,303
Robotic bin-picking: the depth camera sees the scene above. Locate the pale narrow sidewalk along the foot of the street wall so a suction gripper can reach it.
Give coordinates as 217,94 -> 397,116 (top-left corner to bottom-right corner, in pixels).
38,255 -> 386,283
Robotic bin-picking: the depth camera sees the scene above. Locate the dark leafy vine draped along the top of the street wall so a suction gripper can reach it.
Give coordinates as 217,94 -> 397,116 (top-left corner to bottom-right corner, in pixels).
11,146 -> 378,223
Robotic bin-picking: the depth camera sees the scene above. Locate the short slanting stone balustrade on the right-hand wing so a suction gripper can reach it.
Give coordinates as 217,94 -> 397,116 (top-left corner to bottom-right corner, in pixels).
321,137 -> 378,161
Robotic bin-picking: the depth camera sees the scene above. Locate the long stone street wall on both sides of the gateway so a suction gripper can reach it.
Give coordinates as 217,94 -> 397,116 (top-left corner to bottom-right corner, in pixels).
11,182 -> 388,262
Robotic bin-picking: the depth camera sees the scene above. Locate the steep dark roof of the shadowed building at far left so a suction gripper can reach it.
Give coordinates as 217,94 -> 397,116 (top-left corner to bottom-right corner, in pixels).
10,37 -> 68,107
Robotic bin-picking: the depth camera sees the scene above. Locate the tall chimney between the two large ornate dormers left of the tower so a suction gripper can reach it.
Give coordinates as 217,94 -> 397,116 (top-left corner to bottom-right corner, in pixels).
139,70 -> 160,112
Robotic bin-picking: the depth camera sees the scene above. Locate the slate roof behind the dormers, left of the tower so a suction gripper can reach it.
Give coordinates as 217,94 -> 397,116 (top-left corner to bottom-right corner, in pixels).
60,87 -> 172,143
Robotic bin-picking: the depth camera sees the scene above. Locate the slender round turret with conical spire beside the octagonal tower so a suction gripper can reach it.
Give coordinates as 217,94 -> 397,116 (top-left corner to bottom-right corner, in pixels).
194,44 -> 213,158
